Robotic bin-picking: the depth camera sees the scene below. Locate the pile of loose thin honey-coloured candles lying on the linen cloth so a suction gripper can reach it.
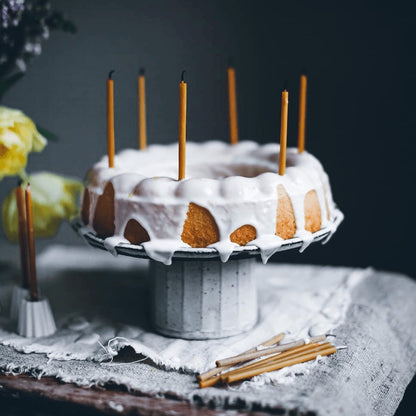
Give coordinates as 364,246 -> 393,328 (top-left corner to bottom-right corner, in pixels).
197,333 -> 337,388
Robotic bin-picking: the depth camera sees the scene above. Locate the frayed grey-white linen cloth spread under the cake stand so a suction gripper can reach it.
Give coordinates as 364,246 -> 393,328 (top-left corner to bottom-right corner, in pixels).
0,246 -> 416,415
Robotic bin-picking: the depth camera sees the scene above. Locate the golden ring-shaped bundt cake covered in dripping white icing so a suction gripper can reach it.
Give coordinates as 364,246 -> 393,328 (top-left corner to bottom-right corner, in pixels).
81,141 -> 335,264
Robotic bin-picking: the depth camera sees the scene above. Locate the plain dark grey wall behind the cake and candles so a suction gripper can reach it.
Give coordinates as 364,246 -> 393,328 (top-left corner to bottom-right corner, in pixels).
0,0 -> 415,275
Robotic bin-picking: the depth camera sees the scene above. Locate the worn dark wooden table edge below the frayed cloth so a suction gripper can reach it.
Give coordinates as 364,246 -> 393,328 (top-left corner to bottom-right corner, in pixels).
0,374 -> 280,416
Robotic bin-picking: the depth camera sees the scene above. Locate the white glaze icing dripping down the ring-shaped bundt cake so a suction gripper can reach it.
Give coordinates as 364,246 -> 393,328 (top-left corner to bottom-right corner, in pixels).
83,141 -> 335,264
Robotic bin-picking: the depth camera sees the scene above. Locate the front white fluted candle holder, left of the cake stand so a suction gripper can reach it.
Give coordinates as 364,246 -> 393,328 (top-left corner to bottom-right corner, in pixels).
17,298 -> 56,337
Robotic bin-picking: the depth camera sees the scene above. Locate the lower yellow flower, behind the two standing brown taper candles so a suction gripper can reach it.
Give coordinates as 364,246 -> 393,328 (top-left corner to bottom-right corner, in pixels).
3,172 -> 83,242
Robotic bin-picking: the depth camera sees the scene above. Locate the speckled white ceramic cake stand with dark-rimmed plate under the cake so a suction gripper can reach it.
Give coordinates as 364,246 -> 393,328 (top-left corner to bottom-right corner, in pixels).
72,210 -> 343,339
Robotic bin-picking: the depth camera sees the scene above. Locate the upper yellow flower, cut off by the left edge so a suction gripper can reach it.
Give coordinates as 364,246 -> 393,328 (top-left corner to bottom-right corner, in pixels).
0,106 -> 46,179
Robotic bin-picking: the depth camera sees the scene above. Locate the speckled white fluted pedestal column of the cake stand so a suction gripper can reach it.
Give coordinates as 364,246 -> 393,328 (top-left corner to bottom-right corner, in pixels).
150,258 -> 257,339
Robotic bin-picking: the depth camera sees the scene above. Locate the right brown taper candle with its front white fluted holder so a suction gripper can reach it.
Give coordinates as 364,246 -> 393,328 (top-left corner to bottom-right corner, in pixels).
17,184 -> 56,337
